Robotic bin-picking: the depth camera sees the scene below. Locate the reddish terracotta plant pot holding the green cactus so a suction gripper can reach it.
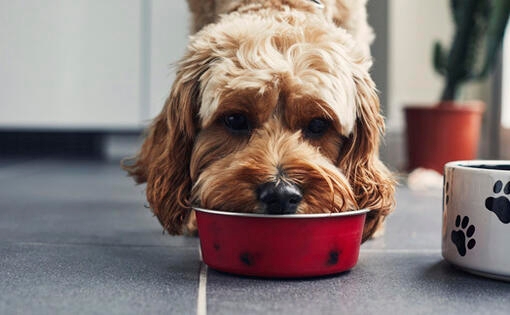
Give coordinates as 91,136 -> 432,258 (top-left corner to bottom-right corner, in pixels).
405,101 -> 485,174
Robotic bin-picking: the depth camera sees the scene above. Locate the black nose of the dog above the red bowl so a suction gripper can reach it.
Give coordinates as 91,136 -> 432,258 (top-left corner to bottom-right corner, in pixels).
257,182 -> 303,214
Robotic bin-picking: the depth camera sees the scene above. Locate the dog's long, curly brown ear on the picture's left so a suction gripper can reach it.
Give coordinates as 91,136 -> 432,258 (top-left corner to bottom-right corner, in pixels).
122,52 -> 212,234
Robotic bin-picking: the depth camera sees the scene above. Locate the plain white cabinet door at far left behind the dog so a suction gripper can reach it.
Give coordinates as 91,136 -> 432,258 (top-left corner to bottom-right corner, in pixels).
0,0 -> 143,129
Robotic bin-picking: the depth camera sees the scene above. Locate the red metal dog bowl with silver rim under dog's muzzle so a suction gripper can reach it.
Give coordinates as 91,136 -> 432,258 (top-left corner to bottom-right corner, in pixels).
195,208 -> 368,278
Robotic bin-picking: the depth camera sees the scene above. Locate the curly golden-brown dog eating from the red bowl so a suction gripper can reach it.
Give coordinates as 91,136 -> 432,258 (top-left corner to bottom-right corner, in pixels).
123,0 -> 395,241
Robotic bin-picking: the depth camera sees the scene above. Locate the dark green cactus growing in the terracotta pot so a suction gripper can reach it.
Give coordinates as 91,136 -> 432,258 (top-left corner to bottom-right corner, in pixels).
433,0 -> 510,101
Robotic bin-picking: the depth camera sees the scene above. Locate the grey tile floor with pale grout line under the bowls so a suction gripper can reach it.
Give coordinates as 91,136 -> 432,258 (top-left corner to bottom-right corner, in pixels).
0,159 -> 510,315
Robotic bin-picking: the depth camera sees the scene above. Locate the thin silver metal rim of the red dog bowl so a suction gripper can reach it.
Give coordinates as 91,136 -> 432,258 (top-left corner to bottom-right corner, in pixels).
193,207 -> 371,219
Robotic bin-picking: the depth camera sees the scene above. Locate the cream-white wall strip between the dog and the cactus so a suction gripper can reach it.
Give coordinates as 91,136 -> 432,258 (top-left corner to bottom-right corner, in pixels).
386,0 -> 453,132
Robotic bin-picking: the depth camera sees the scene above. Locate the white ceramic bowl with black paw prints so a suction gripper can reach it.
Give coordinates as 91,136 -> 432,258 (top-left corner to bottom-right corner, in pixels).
442,160 -> 510,281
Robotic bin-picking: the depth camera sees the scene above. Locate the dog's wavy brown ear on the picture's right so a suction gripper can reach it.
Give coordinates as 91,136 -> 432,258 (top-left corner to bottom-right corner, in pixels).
339,71 -> 395,241
